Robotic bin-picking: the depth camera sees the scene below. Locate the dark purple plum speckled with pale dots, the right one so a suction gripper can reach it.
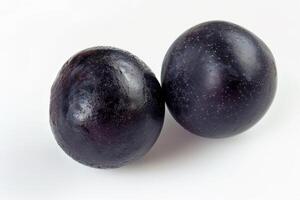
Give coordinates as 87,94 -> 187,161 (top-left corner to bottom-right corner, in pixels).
161,21 -> 277,138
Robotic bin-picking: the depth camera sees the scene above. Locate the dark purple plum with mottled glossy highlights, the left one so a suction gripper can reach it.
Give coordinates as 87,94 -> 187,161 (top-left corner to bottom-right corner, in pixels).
50,47 -> 164,168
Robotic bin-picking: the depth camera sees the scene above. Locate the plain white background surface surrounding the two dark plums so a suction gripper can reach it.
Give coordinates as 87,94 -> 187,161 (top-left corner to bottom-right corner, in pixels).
0,0 -> 300,200
